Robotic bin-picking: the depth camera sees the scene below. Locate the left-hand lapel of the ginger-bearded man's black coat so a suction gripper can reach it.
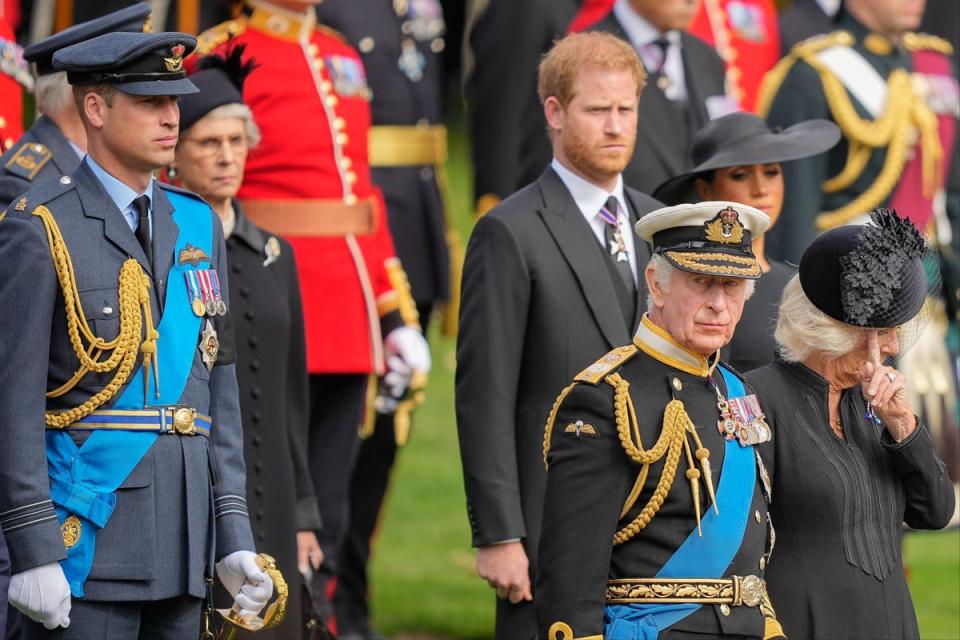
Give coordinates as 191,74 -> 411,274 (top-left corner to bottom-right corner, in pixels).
537,168 -> 630,348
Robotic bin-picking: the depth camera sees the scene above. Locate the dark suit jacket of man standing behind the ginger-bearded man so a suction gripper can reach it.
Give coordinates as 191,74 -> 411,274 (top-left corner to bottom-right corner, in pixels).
590,12 -> 724,193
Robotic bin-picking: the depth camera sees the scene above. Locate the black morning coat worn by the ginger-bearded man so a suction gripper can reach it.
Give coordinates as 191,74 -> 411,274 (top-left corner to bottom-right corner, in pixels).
456,168 -> 660,637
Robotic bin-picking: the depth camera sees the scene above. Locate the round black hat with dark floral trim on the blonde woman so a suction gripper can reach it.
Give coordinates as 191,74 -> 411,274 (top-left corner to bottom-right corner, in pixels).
799,209 -> 928,329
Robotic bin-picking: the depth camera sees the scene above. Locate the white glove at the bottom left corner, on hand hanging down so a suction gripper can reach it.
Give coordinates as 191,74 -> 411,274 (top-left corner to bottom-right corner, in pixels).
9,562 -> 71,629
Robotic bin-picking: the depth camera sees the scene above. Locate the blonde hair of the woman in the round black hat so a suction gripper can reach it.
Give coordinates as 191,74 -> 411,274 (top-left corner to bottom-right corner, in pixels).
773,275 -> 861,362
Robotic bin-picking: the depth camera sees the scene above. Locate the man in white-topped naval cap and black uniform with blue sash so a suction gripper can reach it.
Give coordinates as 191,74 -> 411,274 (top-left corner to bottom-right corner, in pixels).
535,202 -> 782,640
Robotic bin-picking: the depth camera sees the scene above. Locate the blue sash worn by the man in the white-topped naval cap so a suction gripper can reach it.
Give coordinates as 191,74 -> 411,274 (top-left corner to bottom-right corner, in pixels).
603,365 -> 756,640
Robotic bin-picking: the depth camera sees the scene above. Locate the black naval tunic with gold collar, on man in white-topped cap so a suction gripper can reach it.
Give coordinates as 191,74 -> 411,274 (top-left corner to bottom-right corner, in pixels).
534,317 -> 776,640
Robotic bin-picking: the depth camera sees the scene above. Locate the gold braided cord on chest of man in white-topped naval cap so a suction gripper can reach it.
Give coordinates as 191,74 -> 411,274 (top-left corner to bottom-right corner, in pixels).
606,373 -> 717,545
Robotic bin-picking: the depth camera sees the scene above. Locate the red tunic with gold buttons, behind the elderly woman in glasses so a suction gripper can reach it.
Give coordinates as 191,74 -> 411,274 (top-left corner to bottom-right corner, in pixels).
194,2 -> 409,373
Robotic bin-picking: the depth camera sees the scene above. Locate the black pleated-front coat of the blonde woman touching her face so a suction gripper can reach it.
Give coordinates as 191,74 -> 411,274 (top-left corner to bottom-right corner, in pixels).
747,360 -> 955,638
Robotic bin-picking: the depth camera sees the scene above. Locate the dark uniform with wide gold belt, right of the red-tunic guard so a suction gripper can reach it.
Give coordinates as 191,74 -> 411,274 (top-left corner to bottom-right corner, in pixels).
317,0 -> 450,634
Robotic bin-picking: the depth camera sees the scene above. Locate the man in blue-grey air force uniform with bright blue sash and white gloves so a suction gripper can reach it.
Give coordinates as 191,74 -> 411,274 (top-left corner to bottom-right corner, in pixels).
0,28 -> 273,639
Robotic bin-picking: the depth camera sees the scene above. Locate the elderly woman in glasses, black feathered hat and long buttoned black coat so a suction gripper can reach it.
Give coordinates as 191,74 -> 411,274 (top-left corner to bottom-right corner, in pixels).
167,46 -> 323,640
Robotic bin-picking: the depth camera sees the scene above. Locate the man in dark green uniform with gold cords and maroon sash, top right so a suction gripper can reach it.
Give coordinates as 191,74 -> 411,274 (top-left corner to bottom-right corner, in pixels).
757,0 -> 960,482
